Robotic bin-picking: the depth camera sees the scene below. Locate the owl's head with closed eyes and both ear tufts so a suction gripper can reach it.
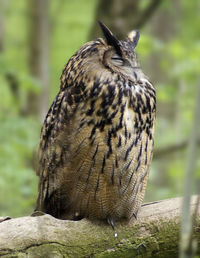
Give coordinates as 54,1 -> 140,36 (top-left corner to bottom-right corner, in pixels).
61,22 -> 144,87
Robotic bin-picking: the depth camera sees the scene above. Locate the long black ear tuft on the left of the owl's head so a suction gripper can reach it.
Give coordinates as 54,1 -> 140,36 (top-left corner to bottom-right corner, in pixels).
99,21 -> 122,56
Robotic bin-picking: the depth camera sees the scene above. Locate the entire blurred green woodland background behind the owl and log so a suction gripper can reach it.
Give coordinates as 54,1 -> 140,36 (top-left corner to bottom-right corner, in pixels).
0,0 -> 200,217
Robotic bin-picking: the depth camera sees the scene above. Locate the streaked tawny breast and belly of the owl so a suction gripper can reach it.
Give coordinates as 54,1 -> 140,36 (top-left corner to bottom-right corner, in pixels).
59,85 -> 153,218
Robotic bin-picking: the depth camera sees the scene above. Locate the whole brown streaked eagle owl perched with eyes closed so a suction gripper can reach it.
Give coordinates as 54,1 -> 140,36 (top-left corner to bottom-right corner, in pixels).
35,22 -> 156,224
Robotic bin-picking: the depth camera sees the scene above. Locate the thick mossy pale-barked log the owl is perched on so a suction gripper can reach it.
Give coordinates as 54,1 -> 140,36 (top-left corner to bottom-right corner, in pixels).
0,196 -> 200,258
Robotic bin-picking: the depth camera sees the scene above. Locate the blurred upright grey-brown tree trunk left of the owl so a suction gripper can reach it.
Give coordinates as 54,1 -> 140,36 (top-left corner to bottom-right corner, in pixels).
27,0 -> 49,120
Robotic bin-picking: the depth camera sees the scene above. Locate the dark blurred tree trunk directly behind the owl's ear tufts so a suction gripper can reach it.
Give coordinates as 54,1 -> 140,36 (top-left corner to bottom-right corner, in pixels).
89,0 -> 161,39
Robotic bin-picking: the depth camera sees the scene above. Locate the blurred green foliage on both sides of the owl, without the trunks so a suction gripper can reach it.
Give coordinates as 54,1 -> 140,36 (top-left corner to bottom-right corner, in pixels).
0,0 -> 200,216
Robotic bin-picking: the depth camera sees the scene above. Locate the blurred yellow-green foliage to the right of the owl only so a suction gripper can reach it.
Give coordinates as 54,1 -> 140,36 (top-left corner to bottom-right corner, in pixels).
137,0 -> 200,201
